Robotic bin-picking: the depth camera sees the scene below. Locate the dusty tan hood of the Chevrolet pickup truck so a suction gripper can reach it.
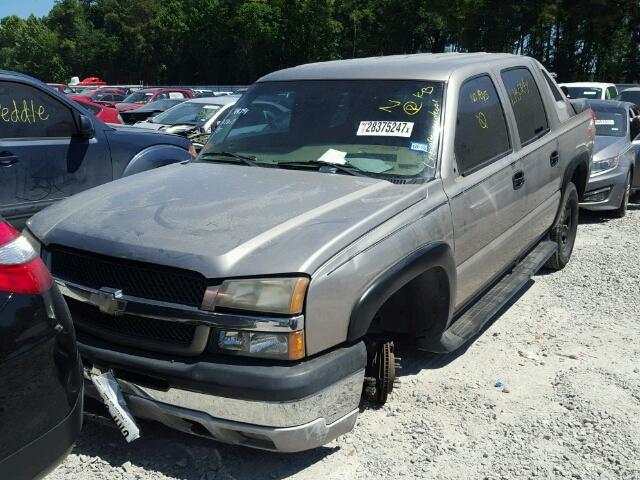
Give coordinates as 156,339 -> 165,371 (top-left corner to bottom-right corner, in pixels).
28,162 -> 426,279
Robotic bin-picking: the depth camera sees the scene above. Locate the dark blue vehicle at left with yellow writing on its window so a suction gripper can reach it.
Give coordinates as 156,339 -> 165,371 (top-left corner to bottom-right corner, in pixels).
0,71 -> 195,225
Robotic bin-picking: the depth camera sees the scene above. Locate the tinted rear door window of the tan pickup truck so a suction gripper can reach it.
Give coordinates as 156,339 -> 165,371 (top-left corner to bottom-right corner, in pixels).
501,68 -> 549,145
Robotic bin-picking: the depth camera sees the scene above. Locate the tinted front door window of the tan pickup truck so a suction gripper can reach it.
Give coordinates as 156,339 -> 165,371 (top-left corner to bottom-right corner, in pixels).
454,75 -> 511,175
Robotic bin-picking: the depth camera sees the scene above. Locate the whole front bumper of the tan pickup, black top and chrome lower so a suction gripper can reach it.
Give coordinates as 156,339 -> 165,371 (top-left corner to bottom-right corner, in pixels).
80,343 -> 366,452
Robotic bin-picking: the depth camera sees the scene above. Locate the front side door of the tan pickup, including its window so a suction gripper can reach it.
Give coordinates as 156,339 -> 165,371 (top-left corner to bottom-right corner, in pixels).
445,74 -> 525,308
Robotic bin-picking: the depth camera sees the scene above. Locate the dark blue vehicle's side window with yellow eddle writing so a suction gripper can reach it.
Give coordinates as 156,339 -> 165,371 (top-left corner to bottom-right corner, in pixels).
0,82 -> 76,138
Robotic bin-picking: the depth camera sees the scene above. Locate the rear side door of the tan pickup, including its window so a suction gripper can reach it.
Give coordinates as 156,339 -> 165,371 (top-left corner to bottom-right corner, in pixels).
500,66 -> 561,242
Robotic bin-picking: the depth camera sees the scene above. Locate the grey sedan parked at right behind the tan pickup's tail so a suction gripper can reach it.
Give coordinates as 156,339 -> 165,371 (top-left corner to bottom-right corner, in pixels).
580,100 -> 640,217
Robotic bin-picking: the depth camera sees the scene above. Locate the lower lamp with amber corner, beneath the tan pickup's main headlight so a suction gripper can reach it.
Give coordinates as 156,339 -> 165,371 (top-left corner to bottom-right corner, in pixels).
216,330 -> 304,360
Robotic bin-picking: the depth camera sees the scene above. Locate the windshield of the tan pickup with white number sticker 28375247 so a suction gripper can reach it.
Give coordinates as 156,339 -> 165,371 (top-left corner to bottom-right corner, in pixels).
199,80 -> 444,178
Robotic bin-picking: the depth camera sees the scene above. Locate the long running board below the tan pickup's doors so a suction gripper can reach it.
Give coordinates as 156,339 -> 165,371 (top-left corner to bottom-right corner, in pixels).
418,240 -> 558,353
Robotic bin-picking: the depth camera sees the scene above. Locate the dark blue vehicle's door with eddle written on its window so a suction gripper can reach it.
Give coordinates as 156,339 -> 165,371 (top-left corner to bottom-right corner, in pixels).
0,81 -> 113,226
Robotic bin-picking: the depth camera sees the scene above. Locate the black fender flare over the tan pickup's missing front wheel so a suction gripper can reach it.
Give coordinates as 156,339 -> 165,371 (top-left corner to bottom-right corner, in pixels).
347,242 -> 457,342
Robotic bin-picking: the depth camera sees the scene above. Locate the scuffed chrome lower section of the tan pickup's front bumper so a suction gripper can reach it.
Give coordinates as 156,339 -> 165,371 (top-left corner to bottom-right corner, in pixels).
85,371 -> 364,452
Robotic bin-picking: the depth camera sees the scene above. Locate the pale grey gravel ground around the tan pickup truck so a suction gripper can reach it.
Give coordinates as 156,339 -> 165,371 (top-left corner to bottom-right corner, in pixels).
47,204 -> 640,480
